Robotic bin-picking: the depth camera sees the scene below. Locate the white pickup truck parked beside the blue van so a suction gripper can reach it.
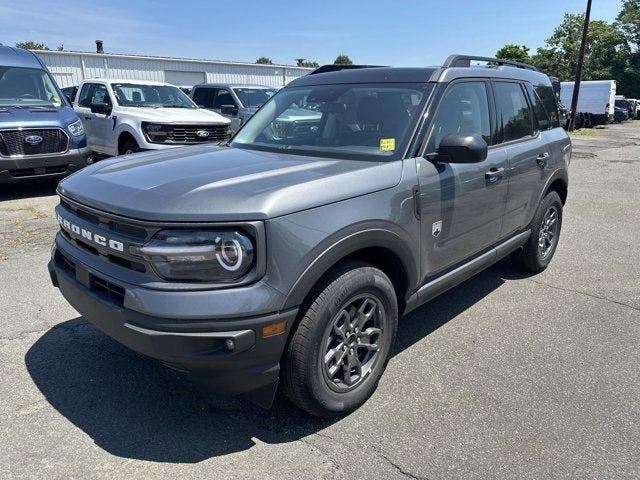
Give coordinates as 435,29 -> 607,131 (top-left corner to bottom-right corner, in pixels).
74,79 -> 230,155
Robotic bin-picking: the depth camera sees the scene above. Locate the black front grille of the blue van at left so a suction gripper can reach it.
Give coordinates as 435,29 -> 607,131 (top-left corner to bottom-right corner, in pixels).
0,128 -> 69,157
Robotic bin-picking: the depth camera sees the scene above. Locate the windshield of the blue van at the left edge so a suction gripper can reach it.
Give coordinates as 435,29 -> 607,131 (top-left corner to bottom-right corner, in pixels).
0,66 -> 63,108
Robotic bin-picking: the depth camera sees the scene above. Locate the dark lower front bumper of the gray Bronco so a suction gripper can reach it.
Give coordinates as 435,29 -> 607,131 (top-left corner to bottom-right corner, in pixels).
48,248 -> 297,406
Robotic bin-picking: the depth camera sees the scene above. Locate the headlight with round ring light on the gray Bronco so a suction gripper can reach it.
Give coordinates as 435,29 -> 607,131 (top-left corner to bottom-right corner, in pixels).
131,230 -> 255,283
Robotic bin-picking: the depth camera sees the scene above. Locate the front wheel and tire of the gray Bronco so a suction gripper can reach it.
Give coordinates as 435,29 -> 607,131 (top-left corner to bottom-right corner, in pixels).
281,261 -> 398,418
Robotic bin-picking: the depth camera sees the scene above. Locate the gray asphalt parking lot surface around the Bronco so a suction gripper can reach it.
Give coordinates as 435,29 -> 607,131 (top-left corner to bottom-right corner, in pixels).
0,122 -> 640,479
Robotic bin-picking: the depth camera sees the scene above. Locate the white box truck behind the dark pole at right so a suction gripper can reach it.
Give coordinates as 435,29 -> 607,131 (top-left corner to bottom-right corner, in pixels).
560,80 -> 616,125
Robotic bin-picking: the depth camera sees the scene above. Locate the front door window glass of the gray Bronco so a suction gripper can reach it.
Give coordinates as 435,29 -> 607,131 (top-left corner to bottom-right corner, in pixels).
427,82 -> 491,153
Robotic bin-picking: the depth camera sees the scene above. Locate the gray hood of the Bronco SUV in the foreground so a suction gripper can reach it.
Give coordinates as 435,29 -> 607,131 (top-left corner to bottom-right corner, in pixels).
58,145 -> 402,221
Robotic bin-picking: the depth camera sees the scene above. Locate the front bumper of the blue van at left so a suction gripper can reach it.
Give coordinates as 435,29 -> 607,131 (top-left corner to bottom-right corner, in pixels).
0,147 -> 91,184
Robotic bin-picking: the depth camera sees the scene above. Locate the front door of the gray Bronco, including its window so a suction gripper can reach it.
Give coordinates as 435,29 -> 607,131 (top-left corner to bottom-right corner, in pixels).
417,81 -> 508,279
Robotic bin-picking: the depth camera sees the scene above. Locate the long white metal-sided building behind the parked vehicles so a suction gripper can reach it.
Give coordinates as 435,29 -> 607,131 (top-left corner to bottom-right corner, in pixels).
34,50 -> 312,88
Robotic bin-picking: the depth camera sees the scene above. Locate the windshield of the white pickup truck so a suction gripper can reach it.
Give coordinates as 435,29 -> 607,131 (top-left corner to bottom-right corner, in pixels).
111,83 -> 198,108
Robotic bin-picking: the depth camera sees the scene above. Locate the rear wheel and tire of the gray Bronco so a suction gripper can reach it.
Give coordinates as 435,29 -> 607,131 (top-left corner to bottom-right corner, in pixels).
511,191 -> 562,273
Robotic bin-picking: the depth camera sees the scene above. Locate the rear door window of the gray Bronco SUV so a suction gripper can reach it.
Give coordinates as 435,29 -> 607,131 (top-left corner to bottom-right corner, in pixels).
494,82 -> 533,142
